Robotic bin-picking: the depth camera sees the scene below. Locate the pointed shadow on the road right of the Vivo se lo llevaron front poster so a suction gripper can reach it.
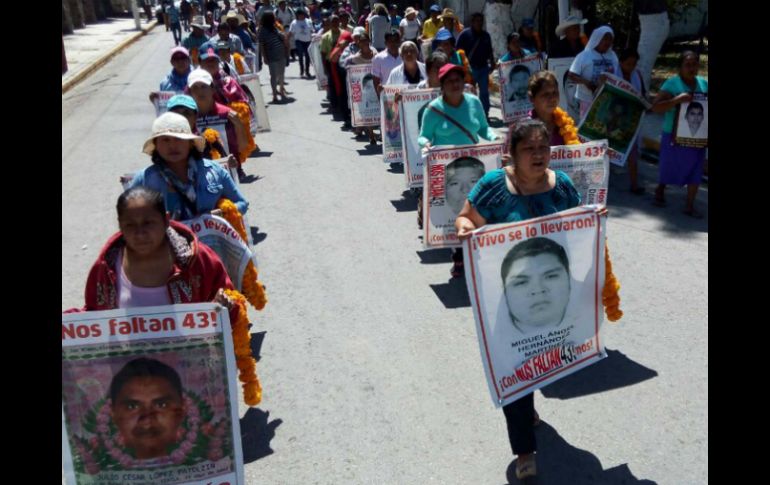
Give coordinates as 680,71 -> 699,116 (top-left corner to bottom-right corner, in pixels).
540,349 -> 658,399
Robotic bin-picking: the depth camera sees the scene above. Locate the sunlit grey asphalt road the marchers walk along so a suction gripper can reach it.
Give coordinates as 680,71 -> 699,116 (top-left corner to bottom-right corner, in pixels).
62,29 -> 708,484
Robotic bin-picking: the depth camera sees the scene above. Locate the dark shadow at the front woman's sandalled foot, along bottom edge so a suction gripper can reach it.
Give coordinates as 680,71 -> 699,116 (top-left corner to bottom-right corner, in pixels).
505,422 -> 656,485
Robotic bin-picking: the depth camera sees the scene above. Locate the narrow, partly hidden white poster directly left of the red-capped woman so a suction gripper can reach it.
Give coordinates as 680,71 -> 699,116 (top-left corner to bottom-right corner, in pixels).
398,88 -> 441,189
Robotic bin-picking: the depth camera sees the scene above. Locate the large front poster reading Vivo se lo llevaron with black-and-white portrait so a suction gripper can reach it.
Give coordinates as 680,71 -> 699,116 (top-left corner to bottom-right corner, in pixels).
463,205 -> 606,407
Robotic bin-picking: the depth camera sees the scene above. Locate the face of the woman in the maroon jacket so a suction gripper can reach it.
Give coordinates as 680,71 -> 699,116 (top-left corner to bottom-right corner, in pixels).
118,198 -> 168,256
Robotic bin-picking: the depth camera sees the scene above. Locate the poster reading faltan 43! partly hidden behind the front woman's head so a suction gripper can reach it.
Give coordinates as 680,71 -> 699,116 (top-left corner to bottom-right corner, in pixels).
548,140 -> 610,205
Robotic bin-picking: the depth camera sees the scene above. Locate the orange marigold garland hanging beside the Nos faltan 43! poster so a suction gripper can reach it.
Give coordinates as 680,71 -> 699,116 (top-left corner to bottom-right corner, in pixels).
225,290 -> 262,406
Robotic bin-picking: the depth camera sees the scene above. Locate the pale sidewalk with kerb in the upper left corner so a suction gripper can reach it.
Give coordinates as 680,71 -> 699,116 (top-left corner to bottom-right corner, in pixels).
61,17 -> 157,93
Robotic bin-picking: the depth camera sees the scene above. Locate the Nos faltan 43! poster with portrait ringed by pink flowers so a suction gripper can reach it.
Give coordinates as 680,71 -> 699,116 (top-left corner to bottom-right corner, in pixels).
62,303 -> 245,485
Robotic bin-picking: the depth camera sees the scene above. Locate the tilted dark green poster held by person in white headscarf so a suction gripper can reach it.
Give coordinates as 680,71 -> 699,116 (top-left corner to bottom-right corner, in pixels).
578,73 -> 650,167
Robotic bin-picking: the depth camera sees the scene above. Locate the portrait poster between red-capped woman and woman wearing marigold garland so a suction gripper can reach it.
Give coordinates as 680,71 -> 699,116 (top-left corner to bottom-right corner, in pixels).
497,54 -> 543,123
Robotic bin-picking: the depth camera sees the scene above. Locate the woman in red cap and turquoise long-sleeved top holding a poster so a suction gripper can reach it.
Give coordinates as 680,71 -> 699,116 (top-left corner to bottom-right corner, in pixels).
418,64 -> 497,278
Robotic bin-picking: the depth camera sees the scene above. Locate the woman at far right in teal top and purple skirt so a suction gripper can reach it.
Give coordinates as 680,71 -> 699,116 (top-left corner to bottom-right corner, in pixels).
652,51 -> 709,219
